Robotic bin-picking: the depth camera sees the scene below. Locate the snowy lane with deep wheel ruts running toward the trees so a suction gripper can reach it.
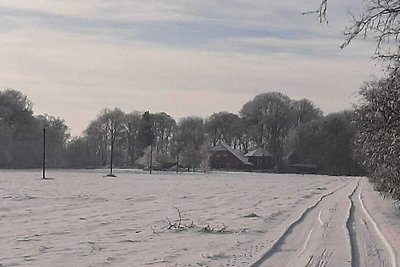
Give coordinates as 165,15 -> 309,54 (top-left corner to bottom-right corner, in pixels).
251,178 -> 397,267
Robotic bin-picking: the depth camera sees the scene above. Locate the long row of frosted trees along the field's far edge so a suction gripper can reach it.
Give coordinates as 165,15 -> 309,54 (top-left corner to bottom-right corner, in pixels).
0,89 -> 362,175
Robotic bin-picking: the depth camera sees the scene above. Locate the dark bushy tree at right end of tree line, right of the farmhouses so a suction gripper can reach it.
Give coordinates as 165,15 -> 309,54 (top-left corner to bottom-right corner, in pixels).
287,111 -> 363,175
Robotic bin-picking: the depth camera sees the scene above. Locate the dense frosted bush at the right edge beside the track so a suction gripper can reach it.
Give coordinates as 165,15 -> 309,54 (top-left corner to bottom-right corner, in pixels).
356,68 -> 400,200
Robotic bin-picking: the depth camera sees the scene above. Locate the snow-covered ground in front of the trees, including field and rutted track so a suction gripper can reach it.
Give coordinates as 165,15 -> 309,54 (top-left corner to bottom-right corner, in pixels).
0,170 -> 400,267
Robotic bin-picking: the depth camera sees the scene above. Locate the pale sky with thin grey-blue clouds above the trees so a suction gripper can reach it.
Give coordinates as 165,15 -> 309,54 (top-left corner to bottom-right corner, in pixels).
0,0 -> 382,135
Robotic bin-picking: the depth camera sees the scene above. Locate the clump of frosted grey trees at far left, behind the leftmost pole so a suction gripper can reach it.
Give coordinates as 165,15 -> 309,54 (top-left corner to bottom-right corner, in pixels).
0,89 -> 74,168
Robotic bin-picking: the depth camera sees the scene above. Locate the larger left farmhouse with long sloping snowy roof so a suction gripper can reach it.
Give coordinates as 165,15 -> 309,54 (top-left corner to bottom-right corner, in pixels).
210,144 -> 254,170
